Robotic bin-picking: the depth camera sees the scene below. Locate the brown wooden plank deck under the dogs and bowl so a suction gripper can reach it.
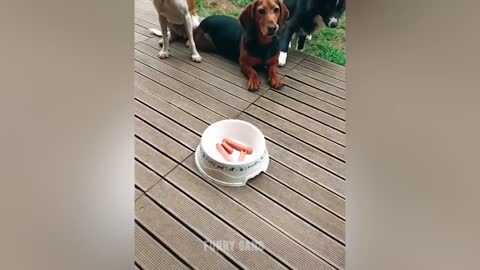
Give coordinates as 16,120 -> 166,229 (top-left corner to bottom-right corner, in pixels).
135,0 -> 346,270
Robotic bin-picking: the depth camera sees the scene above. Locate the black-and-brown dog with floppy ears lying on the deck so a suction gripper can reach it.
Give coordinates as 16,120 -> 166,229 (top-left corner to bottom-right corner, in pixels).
194,0 -> 288,91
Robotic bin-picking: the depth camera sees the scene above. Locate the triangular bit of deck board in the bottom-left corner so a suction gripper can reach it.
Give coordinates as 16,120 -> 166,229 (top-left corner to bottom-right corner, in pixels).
135,225 -> 189,270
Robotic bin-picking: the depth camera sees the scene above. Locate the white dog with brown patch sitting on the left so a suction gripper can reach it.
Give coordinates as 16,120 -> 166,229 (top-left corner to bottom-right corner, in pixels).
150,0 -> 202,62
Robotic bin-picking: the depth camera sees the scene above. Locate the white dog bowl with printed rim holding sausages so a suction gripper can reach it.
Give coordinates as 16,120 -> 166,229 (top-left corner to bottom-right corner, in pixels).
195,119 -> 269,186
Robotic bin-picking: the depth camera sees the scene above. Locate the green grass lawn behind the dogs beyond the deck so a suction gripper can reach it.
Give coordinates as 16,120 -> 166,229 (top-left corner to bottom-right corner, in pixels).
195,0 -> 346,66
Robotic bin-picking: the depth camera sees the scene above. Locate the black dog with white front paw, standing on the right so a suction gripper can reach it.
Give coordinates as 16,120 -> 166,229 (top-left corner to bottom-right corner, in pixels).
278,0 -> 345,66
